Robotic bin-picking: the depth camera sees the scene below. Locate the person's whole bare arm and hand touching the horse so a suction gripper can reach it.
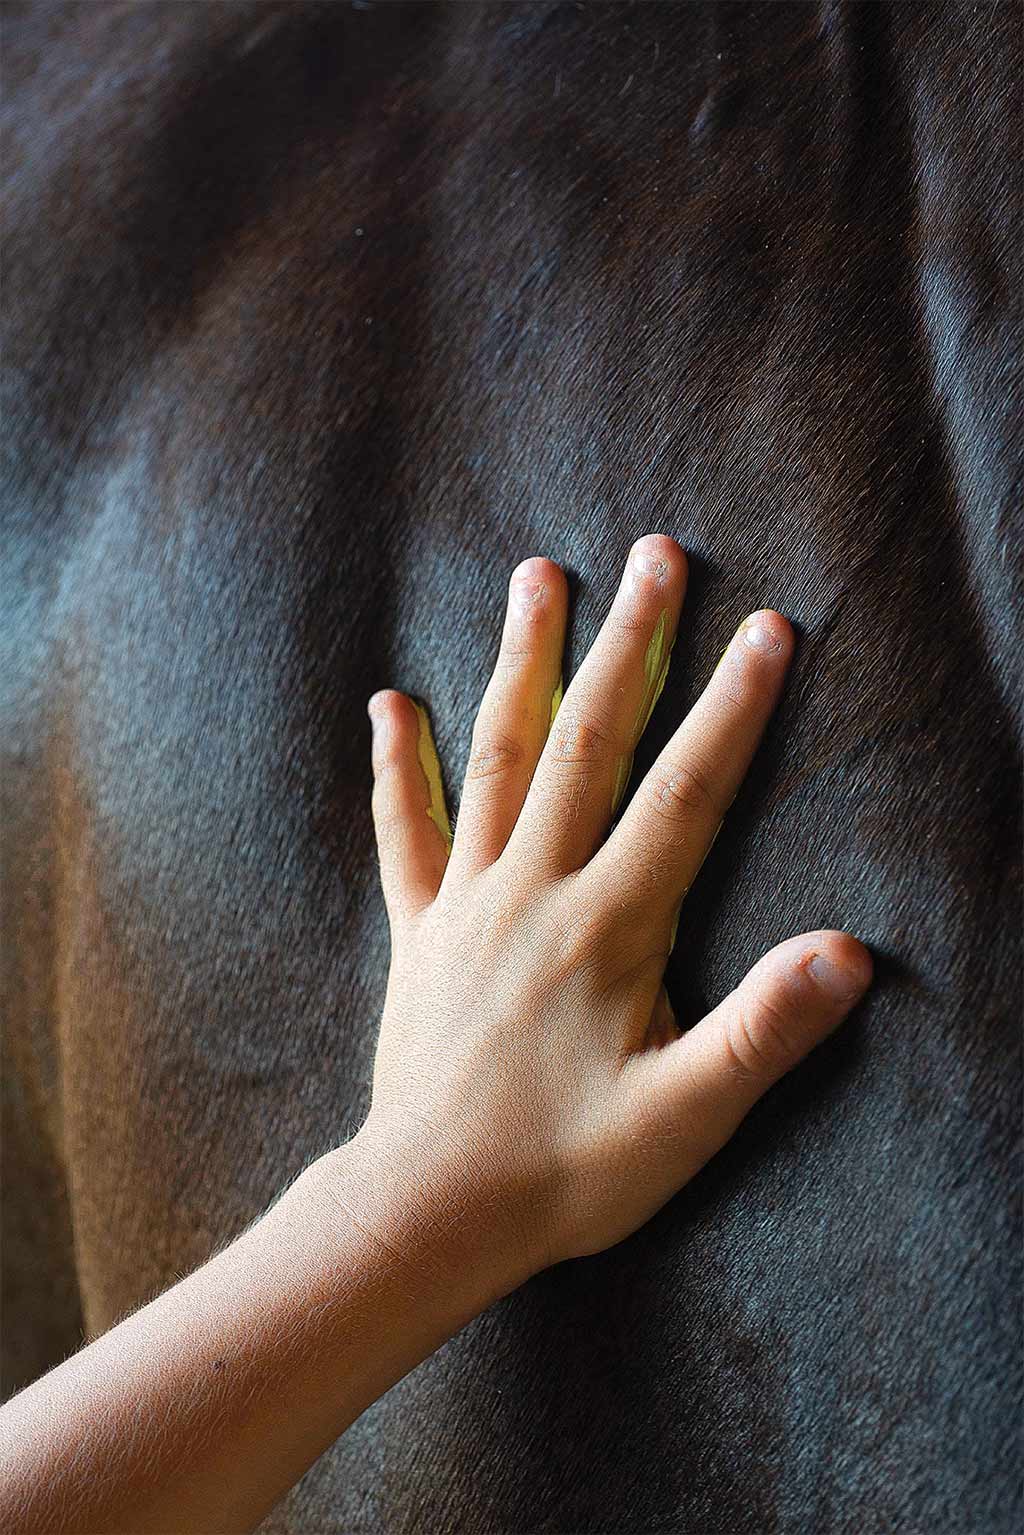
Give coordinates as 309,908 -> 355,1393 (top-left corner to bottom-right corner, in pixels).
0,534 -> 872,1535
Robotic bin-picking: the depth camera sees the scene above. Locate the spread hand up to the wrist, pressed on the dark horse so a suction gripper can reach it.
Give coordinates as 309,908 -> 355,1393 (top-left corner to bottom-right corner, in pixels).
358,536 -> 872,1288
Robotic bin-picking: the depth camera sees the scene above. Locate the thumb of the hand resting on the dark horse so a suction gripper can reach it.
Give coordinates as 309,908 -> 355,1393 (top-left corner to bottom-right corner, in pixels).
646,929 -> 872,1180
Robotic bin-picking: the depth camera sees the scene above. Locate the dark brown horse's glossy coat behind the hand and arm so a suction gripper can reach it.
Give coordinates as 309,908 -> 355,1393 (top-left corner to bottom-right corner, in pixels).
0,3 -> 1022,1535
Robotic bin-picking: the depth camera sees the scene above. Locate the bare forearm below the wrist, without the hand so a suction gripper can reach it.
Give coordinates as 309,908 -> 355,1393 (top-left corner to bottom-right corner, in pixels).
0,1137 -> 514,1535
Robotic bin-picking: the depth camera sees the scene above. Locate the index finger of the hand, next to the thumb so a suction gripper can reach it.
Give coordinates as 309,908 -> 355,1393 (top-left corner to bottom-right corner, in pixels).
583,609 -> 794,923
